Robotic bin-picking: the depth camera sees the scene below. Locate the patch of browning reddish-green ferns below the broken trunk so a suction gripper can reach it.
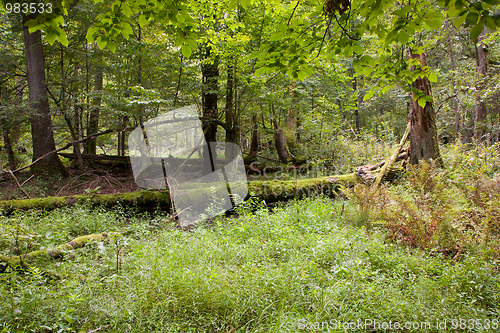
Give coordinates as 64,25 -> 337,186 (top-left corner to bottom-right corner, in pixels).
350,143 -> 500,255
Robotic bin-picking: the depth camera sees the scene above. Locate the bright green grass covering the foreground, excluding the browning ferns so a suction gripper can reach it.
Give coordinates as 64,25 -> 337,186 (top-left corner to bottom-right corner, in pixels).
0,198 -> 500,332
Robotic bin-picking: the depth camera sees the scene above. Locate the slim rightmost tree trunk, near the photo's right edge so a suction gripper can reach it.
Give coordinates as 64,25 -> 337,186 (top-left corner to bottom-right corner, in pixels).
474,27 -> 487,141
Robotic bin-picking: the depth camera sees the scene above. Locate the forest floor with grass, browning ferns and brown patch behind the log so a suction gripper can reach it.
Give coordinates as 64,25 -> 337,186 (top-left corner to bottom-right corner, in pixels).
0,141 -> 500,333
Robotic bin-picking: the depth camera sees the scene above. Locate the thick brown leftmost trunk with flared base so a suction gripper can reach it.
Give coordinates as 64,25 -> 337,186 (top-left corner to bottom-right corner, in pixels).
23,15 -> 69,177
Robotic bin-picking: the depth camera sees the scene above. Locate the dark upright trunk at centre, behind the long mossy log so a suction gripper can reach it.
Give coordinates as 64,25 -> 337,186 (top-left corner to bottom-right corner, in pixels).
201,48 -> 219,173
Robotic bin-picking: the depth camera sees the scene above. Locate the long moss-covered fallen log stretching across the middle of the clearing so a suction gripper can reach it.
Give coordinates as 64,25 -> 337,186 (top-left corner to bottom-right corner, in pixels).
0,169 -> 400,214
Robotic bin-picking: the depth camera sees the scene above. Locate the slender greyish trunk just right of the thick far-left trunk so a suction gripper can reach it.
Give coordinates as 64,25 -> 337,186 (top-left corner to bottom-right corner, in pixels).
86,51 -> 103,154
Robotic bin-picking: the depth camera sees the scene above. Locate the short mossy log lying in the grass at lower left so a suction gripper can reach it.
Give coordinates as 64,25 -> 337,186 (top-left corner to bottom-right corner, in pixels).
0,232 -> 116,271
